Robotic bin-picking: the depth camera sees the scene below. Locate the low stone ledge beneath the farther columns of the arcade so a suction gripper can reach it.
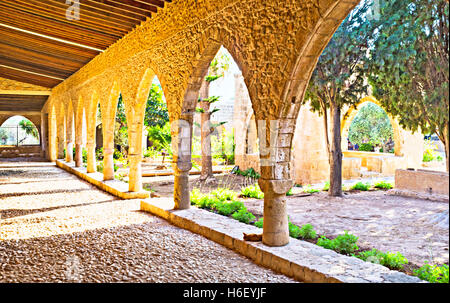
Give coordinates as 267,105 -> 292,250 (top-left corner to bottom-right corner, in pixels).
56,160 -> 150,200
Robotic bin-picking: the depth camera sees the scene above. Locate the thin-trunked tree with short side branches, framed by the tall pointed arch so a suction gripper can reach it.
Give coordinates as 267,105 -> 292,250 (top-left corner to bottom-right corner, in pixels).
196,49 -> 230,182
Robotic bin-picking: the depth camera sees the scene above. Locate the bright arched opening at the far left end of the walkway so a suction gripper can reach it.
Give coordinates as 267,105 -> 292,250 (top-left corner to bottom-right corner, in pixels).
0,115 -> 42,158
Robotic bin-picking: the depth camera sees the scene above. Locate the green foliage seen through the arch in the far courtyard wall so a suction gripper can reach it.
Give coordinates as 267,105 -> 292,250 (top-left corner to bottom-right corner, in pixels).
348,102 -> 394,146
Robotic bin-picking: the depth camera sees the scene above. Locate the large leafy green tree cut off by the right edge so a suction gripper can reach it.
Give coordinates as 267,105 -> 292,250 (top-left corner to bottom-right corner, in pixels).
368,0 -> 449,171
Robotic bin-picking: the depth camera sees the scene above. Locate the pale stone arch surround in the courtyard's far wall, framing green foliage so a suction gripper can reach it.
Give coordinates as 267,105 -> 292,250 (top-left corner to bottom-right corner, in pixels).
341,96 -> 403,157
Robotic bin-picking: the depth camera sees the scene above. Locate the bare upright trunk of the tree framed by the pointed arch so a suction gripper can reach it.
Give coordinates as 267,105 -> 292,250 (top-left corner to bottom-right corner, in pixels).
199,80 -> 215,182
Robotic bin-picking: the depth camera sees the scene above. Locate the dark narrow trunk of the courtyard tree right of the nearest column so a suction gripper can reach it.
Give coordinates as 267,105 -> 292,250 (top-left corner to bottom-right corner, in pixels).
328,102 -> 342,197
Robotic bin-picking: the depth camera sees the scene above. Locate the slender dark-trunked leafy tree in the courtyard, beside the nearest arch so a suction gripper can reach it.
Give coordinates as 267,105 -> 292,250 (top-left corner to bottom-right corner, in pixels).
305,2 -> 371,196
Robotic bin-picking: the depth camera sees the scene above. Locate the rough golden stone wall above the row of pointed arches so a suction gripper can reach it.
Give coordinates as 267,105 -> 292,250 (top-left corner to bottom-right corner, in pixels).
42,0 -> 358,180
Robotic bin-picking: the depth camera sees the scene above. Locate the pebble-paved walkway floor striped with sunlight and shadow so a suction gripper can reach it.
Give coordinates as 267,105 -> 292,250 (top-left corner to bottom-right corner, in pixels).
0,160 -> 294,283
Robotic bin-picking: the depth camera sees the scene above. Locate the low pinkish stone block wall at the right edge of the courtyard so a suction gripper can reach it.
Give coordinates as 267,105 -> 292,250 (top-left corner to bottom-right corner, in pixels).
395,169 -> 449,197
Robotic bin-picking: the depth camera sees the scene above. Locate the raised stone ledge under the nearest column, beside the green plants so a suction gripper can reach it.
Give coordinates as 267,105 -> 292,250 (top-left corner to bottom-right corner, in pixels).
141,199 -> 424,283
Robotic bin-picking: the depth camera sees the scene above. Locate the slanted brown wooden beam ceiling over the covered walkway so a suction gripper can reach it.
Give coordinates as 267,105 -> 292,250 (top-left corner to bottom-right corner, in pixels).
0,0 -> 172,112
